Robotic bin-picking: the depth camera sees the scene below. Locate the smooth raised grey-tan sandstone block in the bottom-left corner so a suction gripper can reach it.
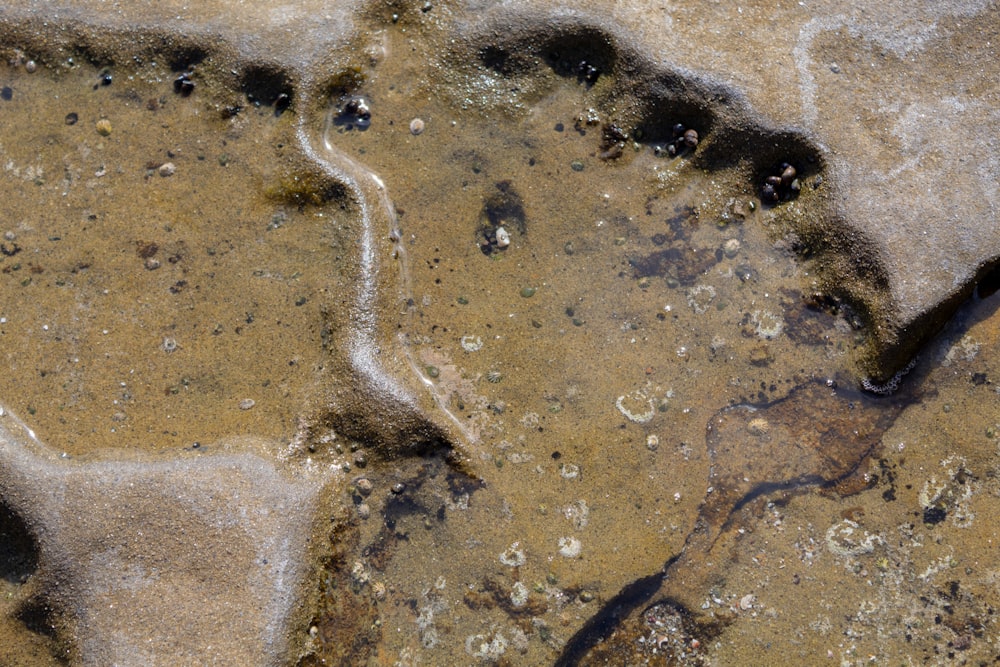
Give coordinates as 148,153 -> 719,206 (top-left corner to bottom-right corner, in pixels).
0,413 -> 336,665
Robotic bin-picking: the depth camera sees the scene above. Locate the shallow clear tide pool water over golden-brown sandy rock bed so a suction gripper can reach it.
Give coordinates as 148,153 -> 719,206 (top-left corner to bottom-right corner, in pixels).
0,6 -> 1000,665
